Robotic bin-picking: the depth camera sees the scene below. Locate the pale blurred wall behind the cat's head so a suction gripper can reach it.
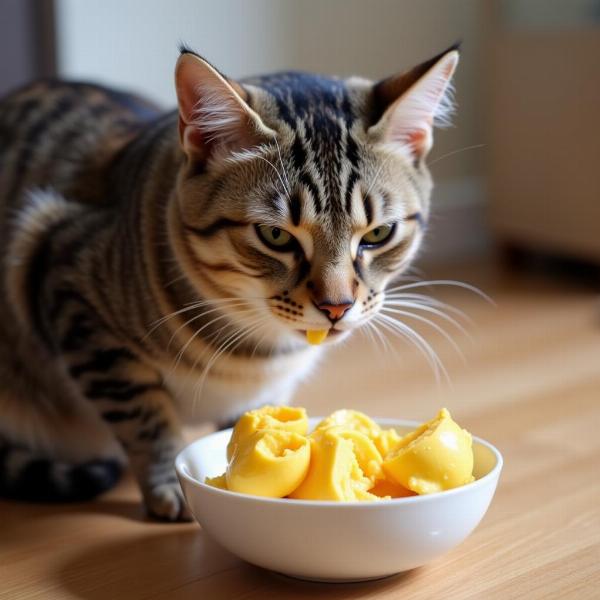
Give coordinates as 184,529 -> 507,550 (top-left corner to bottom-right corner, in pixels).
56,0 -> 482,180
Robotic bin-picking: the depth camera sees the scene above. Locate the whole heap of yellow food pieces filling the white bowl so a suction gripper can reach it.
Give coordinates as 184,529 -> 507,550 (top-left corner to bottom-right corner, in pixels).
205,406 -> 474,502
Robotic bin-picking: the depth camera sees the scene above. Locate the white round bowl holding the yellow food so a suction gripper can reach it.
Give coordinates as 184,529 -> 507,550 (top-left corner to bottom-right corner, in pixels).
175,418 -> 502,581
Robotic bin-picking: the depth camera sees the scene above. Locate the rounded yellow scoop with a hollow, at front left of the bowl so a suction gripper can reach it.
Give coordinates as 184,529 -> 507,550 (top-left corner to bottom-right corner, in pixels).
225,429 -> 310,498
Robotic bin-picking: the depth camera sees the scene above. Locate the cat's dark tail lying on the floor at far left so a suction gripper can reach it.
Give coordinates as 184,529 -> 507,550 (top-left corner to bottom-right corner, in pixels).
0,439 -> 123,502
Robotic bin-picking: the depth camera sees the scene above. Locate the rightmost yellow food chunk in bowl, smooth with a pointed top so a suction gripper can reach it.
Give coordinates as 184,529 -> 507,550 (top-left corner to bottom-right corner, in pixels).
383,408 -> 473,494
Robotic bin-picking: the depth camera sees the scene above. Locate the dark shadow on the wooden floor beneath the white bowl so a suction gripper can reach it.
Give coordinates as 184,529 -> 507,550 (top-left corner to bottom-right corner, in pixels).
56,526 -> 418,600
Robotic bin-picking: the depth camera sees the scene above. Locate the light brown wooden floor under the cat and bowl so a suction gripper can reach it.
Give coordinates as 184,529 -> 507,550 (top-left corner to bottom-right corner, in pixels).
0,267 -> 600,600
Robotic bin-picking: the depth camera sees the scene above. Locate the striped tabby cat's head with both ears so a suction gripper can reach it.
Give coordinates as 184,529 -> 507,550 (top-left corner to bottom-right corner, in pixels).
170,47 -> 458,343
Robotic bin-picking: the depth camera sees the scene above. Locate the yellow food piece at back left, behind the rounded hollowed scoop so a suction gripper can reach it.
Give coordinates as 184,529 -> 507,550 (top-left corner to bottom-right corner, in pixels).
227,406 -> 308,460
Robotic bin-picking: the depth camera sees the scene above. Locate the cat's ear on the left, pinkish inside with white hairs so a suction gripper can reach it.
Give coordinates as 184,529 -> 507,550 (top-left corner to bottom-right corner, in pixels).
175,50 -> 274,161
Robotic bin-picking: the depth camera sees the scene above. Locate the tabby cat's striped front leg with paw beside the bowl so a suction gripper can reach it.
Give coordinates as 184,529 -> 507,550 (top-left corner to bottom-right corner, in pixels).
61,313 -> 190,521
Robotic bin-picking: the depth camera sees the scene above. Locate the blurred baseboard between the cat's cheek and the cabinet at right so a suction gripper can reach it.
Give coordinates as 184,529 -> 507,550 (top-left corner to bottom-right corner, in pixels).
419,177 -> 492,263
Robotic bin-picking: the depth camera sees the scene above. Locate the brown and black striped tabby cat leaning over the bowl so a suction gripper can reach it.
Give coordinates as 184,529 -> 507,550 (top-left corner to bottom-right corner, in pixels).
0,46 -> 459,521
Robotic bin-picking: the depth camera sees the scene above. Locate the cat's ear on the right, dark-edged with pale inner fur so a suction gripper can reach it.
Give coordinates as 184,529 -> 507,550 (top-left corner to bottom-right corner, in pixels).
369,46 -> 458,160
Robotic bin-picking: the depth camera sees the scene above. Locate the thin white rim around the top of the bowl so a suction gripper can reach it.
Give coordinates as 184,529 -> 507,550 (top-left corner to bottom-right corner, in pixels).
175,417 -> 504,510
